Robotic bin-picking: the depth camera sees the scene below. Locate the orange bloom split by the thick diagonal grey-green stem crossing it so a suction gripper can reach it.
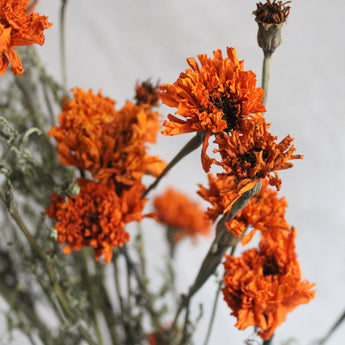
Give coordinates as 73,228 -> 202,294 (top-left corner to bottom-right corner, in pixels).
198,174 -> 290,245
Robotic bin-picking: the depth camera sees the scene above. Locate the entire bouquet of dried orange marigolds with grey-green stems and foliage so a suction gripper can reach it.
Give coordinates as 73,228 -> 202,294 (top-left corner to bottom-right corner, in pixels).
0,0 -> 342,345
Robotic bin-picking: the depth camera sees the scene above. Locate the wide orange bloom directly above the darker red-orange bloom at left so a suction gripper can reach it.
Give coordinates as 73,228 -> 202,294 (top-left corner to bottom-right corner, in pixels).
49,89 -> 165,185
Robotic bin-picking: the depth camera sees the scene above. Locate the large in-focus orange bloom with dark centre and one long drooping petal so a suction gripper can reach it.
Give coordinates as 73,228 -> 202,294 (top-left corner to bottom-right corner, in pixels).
160,48 -> 266,171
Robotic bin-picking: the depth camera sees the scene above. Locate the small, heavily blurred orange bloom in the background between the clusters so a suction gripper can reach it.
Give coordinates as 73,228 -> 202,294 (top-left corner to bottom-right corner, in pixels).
154,188 -> 211,241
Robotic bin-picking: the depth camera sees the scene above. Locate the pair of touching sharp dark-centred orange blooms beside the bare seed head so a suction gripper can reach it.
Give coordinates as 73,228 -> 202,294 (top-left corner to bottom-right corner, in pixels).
160,48 -> 303,211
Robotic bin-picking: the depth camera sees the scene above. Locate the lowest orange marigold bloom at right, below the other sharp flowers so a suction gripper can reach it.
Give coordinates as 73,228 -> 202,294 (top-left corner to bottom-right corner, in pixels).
223,228 -> 315,340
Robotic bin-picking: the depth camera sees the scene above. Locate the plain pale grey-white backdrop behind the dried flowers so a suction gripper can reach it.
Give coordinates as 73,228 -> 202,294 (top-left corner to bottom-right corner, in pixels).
7,0 -> 345,345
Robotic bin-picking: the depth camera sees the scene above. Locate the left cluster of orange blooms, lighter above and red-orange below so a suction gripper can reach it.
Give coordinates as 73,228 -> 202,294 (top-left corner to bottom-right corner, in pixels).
46,89 -> 165,262
